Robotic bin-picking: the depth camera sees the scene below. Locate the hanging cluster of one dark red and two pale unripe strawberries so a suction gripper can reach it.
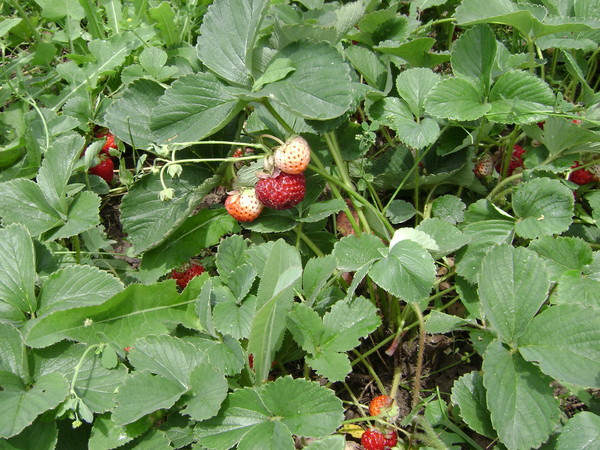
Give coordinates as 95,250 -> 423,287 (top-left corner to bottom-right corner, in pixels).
225,136 -> 310,222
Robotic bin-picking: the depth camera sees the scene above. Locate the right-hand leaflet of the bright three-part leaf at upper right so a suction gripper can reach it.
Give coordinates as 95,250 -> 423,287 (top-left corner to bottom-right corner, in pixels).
486,70 -> 555,124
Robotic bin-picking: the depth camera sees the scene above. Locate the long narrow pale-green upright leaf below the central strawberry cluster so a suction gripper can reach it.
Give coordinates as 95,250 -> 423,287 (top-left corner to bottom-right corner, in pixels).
248,240 -> 302,382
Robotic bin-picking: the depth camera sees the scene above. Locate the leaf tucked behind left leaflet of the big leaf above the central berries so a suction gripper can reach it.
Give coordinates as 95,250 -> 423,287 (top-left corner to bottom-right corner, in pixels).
104,79 -> 165,148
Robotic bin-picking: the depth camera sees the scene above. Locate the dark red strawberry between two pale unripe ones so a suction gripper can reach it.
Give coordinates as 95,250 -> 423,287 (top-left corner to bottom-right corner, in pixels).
255,172 -> 306,209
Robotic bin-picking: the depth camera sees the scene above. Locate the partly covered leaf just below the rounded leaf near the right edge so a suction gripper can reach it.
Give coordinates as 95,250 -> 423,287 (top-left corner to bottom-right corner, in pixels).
528,236 -> 593,281
